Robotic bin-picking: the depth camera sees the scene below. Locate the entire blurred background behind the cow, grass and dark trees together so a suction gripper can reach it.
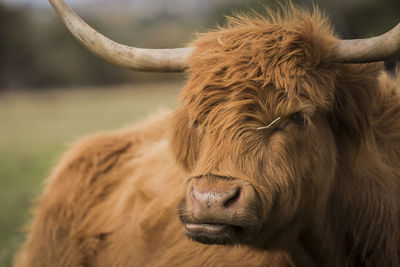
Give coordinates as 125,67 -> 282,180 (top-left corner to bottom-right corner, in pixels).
0,0 -> 400,267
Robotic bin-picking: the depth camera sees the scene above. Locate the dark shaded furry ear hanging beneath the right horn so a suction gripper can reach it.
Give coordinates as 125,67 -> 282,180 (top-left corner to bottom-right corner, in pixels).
330,63 -> 382,147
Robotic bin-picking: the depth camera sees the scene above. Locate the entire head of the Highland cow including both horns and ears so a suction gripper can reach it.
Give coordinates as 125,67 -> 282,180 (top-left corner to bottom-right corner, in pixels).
50,0 -> 400,250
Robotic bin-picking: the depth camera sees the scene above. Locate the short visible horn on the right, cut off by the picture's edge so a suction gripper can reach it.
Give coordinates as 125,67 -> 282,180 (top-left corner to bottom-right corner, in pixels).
334,23 -> 400,63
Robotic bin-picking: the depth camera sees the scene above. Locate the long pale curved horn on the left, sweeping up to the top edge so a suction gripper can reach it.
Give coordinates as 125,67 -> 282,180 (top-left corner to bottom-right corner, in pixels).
49,0 -> 193,72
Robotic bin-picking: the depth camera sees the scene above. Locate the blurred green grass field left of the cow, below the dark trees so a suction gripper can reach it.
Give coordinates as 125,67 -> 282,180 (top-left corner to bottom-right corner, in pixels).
0,82 -> 181,267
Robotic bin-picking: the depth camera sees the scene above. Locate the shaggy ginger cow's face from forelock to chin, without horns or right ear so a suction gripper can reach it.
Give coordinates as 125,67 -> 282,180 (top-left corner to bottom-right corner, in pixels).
171,17 -> 336,247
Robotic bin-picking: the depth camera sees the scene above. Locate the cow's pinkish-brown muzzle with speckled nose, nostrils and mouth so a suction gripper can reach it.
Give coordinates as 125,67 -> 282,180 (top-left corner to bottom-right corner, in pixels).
179,175 -> 260,244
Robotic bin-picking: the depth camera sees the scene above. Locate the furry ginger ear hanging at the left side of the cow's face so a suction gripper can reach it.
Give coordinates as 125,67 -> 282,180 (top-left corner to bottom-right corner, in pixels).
170,109 -> 199,171
